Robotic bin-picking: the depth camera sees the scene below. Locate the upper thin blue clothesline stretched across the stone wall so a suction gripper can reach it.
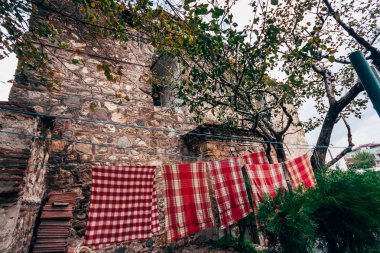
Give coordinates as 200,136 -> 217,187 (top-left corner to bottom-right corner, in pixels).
0,108 -> 347,149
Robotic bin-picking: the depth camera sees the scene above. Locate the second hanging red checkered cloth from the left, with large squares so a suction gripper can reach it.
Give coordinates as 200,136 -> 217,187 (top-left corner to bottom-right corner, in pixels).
163,162 -> 214,243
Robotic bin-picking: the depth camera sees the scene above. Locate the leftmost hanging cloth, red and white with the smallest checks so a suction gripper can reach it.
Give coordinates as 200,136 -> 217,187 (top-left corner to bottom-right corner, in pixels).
85,166 -> 159,249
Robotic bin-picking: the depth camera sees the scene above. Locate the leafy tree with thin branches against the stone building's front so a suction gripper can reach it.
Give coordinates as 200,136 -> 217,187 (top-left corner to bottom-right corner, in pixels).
132,1 -> 328,161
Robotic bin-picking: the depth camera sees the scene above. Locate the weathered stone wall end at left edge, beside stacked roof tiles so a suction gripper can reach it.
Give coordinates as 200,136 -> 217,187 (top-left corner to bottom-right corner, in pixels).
0,103 -> 49,252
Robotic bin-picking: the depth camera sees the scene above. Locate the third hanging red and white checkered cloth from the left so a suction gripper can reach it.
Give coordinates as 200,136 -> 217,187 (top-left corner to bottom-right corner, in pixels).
209,158 -> 252,228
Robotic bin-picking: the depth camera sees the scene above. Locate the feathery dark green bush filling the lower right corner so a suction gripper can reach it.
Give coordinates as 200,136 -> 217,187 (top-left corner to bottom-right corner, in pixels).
258,171 -> 380,253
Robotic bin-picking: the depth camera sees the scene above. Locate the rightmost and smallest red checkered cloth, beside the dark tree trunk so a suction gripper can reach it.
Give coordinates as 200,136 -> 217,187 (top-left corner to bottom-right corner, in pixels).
285,154 -> 317,188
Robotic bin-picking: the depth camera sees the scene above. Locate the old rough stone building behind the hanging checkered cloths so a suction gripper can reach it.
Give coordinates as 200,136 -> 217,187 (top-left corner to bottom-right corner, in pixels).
0,2 -> 306,253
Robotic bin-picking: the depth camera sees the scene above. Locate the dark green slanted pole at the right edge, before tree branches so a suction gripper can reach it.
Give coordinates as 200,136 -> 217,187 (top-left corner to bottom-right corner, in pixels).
349,51 -> 380,117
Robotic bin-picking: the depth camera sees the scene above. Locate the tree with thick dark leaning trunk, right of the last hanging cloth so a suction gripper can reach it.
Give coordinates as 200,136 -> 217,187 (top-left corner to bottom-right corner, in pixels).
268,0 -> 380,168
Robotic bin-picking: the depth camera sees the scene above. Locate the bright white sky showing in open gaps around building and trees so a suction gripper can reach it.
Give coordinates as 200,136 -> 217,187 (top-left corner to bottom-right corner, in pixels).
0,0 -> 380,166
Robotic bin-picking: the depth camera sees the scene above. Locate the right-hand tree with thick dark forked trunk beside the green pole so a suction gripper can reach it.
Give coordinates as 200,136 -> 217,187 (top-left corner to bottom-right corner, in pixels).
294,0 -> 380,170
